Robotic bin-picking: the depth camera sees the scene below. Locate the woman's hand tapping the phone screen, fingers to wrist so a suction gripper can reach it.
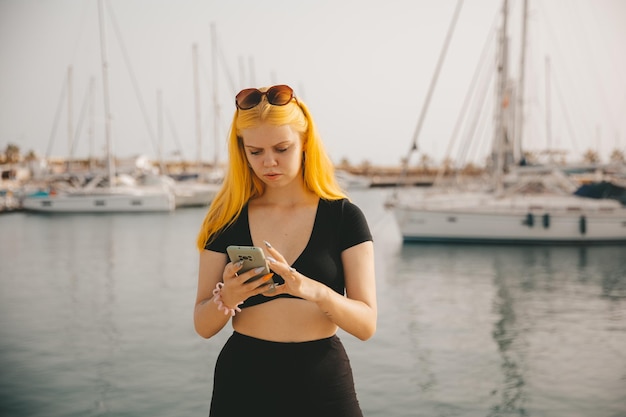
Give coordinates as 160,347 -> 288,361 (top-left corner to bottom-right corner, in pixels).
263,241 -> 326,301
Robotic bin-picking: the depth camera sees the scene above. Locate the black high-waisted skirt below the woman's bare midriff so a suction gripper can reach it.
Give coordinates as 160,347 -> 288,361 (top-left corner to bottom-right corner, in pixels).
209,332 -> 363,417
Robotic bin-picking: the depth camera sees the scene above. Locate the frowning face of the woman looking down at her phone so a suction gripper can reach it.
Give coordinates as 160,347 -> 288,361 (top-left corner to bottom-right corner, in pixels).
241,123 -> 302,187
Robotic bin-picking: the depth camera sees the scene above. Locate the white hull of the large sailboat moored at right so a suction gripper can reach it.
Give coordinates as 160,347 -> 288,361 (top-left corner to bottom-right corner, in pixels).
393,194 -> 626,244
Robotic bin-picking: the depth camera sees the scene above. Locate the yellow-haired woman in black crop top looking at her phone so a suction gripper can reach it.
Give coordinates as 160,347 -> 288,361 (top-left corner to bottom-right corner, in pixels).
194,85 -> 377,417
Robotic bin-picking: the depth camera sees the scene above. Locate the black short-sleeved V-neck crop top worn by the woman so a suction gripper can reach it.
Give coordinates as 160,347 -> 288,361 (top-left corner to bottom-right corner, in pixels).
205,199 -> 372,308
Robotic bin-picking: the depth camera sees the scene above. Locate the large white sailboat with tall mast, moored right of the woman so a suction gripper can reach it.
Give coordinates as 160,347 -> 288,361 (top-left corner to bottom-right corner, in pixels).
386,0 -> 626,244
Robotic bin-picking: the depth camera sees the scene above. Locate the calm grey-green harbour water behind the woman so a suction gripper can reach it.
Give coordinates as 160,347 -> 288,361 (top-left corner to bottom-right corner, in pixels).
0,190 -> 626,417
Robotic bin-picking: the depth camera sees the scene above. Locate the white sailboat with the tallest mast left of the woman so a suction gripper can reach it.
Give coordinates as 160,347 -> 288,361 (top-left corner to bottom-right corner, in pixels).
22,0 -> 175,213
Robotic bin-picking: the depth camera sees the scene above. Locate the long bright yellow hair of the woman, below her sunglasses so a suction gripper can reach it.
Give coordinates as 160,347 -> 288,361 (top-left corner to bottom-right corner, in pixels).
197,89 -> 347,250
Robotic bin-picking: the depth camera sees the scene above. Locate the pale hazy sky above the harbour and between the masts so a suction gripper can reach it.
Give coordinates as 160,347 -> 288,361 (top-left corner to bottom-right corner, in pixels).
0,0 -> 626,165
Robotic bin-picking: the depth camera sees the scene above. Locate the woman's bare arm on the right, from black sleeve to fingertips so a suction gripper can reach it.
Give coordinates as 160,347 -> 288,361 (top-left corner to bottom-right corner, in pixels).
268,241 -> 378,340
